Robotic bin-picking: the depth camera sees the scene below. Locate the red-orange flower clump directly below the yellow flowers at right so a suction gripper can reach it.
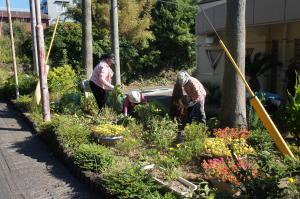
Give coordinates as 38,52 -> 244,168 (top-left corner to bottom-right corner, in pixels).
201,157 -> 257,185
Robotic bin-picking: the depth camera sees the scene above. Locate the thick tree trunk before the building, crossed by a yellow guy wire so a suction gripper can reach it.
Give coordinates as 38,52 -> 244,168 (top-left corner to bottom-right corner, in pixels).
220,0 -> 247,127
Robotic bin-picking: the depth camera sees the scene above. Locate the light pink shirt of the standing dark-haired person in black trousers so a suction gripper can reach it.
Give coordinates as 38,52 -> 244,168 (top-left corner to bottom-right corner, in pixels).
91,61 -> 114,90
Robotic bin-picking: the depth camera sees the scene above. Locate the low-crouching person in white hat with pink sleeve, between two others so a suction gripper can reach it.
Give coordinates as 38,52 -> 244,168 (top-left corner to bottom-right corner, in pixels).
123,91 -> 147,116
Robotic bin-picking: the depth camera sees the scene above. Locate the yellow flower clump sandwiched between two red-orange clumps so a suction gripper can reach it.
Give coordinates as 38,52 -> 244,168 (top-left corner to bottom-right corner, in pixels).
204,138 -> 254,157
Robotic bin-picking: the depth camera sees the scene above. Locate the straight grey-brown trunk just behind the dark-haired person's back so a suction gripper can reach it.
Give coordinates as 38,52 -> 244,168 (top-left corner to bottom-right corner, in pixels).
82,0 -> 93,79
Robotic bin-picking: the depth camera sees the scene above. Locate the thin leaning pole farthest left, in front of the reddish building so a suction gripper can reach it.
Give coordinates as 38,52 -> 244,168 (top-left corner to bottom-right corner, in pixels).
6,0 -> 19,98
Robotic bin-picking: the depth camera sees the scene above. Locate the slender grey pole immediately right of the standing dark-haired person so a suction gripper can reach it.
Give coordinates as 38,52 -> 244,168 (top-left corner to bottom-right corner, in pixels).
110,0 -> 121,85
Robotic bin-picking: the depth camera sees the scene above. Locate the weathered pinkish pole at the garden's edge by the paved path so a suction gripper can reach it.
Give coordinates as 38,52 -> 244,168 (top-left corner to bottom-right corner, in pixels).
35,0 -> 51,122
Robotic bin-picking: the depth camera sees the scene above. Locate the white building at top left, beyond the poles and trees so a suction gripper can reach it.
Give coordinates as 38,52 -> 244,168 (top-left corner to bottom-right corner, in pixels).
41,0 -> 75,24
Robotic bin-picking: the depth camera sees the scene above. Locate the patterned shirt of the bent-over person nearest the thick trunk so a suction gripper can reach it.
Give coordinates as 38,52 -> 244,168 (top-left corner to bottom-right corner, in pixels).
183,77 -> 206,102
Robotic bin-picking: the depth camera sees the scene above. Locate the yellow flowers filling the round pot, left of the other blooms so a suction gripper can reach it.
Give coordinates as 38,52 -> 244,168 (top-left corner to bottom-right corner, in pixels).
92,124 -> 125,136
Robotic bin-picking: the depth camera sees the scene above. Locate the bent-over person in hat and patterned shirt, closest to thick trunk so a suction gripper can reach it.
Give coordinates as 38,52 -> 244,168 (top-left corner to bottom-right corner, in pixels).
177,71 -> 206,123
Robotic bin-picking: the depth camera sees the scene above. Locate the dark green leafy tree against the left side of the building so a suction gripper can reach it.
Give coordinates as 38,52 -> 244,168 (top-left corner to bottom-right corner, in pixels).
151,0 -> 198,68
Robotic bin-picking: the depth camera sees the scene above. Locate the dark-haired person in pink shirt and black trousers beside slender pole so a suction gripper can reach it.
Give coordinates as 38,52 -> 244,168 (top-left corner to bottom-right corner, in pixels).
90,53 -> 115,110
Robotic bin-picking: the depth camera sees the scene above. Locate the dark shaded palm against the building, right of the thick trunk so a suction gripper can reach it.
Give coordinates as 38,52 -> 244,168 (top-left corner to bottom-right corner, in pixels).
245,52 -> 281,91
